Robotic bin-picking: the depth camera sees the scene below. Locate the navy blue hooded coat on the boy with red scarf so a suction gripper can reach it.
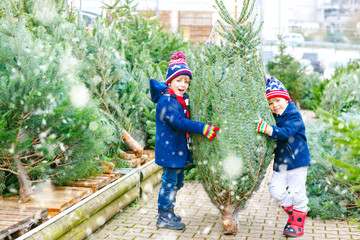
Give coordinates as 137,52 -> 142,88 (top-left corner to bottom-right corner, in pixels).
150,79 -> 205,168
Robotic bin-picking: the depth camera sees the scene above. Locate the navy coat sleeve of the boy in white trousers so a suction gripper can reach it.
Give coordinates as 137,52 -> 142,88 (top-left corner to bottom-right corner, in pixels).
270,113 -> 303,140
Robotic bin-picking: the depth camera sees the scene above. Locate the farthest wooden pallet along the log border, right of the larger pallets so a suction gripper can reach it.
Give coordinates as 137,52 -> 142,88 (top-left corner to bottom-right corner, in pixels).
68,172 -> 121,193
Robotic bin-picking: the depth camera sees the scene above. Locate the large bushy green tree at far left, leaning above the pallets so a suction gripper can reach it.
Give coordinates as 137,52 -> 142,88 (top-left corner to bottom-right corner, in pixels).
0,1 -> 109,201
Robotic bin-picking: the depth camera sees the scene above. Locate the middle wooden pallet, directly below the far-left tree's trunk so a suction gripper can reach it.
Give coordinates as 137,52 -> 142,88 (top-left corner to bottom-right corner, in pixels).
0,186 -> 92,217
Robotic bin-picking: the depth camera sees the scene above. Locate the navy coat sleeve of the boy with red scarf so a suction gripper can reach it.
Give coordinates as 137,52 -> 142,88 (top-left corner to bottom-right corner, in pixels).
156,98 -> 205,134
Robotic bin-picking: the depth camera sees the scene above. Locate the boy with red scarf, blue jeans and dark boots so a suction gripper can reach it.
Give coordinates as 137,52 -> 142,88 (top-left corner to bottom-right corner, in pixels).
150,52 -> 219,230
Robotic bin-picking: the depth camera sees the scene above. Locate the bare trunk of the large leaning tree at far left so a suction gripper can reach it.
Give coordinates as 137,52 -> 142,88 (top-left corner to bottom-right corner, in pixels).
14,156 -> 34,202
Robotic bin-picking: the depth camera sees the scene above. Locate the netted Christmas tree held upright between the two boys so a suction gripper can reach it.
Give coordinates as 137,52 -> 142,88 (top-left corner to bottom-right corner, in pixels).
190,0 -> 274,233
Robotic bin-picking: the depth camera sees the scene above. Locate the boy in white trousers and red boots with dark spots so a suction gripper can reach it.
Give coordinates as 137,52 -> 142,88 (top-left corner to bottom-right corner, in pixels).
256,77 -> 311,237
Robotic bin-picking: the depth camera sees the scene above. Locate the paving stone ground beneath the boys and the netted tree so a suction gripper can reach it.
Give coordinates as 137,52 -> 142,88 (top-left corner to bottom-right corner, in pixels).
88,168 -> 360,240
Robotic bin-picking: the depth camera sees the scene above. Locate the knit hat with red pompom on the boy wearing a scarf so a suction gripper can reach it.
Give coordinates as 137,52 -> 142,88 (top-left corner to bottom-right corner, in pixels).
166,52 -> 192,85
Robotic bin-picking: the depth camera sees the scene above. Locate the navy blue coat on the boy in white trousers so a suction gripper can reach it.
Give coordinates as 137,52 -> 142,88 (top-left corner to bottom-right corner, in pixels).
270,101 -> 311,172
